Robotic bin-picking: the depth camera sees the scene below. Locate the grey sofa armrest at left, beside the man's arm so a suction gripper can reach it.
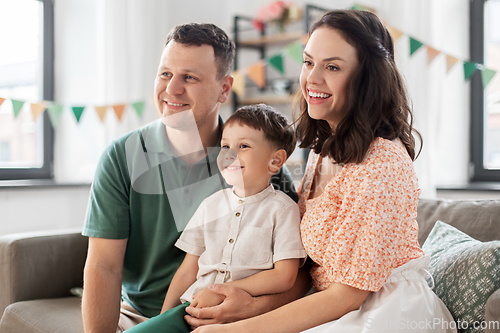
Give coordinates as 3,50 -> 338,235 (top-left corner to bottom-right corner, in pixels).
0,229 -> 88,317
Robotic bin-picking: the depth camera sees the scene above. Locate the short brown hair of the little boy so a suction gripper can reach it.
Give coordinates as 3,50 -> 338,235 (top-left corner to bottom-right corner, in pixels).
222,104 -> 297,159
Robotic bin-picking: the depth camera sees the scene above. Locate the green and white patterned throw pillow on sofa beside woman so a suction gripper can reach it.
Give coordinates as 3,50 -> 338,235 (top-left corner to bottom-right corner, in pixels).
422,221 -> 500,328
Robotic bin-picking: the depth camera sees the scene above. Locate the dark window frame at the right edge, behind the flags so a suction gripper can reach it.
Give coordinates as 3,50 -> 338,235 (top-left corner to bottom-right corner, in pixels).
469,0 -> 500,182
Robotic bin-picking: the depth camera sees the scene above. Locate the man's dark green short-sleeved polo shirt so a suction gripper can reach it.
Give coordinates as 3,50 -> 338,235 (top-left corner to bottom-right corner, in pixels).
83,118 -> 298,317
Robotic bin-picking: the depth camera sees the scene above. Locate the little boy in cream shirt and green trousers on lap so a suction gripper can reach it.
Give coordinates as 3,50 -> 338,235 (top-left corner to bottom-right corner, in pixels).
127,104 -> 306,333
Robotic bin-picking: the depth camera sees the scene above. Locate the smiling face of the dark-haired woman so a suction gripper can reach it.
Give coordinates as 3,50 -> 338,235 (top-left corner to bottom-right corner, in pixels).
300,27 -> 359,129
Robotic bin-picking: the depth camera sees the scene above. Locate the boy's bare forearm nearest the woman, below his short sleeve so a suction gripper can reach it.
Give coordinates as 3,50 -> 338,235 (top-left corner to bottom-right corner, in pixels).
226,259 -> 300,296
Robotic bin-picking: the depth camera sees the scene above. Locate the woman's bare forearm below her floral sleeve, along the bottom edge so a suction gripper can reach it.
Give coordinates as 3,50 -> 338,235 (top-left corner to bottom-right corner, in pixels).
193,283 -> 370,333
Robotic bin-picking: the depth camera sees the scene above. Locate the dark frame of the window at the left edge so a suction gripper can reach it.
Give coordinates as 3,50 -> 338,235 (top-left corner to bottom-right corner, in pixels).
0,0 -> 54,180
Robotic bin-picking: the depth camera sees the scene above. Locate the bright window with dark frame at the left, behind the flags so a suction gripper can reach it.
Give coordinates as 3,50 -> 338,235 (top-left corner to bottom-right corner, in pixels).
0,0 -> 54,180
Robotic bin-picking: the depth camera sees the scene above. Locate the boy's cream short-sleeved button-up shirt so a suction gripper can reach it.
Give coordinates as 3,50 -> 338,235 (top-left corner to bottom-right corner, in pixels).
175,185 -> 307,302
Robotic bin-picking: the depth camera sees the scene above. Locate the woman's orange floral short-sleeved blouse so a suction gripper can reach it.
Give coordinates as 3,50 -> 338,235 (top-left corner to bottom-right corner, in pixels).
299,138 -> 424,291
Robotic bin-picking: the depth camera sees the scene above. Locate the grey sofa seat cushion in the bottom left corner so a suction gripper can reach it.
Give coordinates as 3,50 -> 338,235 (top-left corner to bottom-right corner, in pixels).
0,297 -> 83,333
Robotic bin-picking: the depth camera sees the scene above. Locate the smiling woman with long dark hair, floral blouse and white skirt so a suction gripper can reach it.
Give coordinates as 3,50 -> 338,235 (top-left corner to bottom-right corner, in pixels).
195,10 -> 455,333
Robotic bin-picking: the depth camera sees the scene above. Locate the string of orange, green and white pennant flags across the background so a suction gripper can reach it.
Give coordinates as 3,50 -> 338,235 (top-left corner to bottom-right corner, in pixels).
0,4 -> 498,128
